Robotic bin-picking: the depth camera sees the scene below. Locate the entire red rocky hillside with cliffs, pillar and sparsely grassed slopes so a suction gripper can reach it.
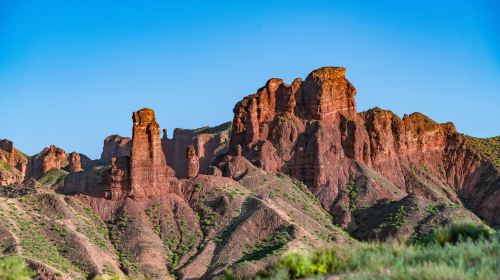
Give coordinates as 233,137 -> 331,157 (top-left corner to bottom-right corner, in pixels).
0,67 -> 500,279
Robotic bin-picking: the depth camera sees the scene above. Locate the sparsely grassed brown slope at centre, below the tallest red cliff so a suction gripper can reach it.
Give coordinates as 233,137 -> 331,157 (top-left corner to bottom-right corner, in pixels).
178,169 -> 354,279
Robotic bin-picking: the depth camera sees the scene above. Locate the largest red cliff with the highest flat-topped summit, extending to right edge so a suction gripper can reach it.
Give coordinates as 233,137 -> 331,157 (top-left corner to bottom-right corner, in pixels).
229,67 -> 500,226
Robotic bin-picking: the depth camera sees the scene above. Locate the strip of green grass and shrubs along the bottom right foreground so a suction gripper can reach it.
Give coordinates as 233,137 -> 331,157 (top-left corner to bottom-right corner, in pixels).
260,226 -> 500,279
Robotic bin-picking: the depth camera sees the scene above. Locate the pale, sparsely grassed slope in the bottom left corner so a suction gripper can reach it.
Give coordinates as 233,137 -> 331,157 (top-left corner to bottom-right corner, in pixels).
0,187 -> 120,279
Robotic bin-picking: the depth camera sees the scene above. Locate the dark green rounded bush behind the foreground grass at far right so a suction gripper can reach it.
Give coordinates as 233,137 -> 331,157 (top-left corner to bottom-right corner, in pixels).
417,222 -> 494,246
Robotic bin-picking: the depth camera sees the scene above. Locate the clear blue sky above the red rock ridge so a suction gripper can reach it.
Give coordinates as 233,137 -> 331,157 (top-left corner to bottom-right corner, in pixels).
0,0 -> 500,158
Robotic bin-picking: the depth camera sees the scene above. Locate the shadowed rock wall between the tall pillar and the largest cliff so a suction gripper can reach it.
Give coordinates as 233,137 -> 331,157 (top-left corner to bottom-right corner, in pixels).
162,122 -> 231,178
